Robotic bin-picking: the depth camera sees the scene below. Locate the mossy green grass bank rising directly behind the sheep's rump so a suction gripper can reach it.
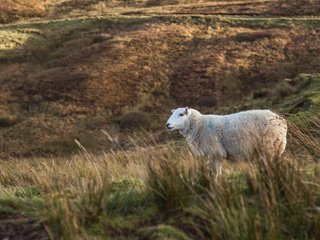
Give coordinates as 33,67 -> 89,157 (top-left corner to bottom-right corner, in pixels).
232,74 -> 320,126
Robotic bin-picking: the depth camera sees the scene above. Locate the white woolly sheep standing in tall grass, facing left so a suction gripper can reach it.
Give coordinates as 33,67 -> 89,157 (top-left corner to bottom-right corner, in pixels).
166,107 -> 287,178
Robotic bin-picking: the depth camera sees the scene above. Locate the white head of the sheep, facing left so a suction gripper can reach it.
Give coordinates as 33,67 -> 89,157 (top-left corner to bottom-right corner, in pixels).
166,107 -> 191,130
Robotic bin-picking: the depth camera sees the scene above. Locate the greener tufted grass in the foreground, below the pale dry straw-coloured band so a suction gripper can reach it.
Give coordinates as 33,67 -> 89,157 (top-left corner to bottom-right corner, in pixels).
0,148 -> 320,239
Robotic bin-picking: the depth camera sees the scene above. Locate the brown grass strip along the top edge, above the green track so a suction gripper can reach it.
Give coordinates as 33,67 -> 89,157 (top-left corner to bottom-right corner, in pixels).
0,0 -> 319,22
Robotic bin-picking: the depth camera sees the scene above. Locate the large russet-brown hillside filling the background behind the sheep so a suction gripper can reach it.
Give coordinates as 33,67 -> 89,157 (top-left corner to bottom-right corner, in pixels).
0,1 -> 320,156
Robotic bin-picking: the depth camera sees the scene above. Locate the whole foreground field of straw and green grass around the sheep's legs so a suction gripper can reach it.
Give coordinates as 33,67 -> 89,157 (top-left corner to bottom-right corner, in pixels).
0,116 -> 320,239
